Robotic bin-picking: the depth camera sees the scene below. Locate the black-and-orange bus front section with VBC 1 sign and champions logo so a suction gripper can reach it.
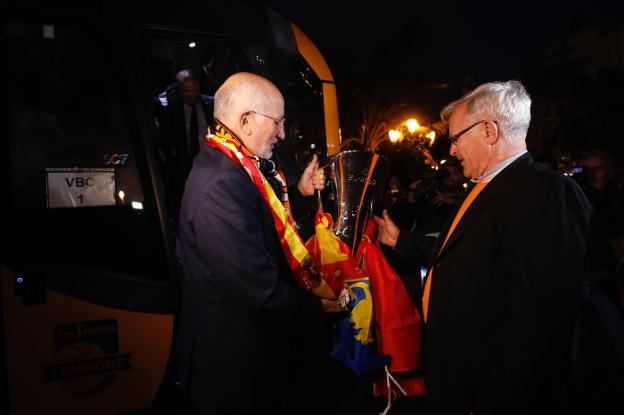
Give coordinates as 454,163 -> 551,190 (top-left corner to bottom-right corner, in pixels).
0,18 -> 174,414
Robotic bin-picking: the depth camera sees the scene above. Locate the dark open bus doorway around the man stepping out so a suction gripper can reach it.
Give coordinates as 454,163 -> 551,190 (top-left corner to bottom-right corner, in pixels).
142,23 -> 250,231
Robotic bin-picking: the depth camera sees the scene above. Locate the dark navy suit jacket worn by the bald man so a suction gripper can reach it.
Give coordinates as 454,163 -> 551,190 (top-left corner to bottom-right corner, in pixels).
177,146 -> 322,411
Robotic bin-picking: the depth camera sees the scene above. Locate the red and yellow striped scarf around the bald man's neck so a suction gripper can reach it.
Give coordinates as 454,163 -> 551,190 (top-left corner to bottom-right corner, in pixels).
205,122 -> 343,299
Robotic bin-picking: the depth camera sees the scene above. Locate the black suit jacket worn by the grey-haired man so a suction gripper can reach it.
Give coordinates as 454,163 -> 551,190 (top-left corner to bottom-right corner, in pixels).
397,154 -> 589,415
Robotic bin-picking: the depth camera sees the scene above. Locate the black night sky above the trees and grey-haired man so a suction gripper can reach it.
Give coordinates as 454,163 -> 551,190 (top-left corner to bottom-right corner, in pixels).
267,0 -> 623,82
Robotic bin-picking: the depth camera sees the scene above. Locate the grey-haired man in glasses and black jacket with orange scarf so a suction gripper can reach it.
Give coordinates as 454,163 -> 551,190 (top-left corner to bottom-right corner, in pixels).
377,81 -> 589,415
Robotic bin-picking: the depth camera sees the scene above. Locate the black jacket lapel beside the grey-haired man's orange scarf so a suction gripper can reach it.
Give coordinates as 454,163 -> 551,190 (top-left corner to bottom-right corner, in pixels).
436,153 -> 532,262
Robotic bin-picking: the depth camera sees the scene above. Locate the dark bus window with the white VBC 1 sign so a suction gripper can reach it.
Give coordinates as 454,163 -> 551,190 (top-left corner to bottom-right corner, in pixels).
2,22 -> 168,279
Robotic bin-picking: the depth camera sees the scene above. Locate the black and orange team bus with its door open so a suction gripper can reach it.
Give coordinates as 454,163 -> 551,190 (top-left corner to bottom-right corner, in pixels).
0,0 -> 340,415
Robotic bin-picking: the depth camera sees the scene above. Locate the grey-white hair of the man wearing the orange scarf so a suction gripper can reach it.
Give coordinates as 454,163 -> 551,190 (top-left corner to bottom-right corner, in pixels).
440,80 -> 531,140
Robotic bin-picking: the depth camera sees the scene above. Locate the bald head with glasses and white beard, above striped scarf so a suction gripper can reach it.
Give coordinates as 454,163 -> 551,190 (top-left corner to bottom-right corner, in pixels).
214,72 -> 285,158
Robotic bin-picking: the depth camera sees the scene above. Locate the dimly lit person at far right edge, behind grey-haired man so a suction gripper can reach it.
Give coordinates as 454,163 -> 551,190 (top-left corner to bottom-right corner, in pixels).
573,150 -> 624,413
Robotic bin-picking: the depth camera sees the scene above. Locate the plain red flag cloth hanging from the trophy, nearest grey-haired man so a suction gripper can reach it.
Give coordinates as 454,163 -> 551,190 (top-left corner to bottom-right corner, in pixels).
357,218 -> 425,406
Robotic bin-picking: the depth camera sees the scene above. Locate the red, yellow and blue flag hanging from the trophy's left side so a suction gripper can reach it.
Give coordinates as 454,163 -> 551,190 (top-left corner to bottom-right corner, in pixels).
306,209 -> 389,375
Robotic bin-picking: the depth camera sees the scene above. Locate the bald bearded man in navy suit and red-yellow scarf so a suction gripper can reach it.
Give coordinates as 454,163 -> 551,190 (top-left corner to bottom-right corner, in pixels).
177,72 -> 338,414
